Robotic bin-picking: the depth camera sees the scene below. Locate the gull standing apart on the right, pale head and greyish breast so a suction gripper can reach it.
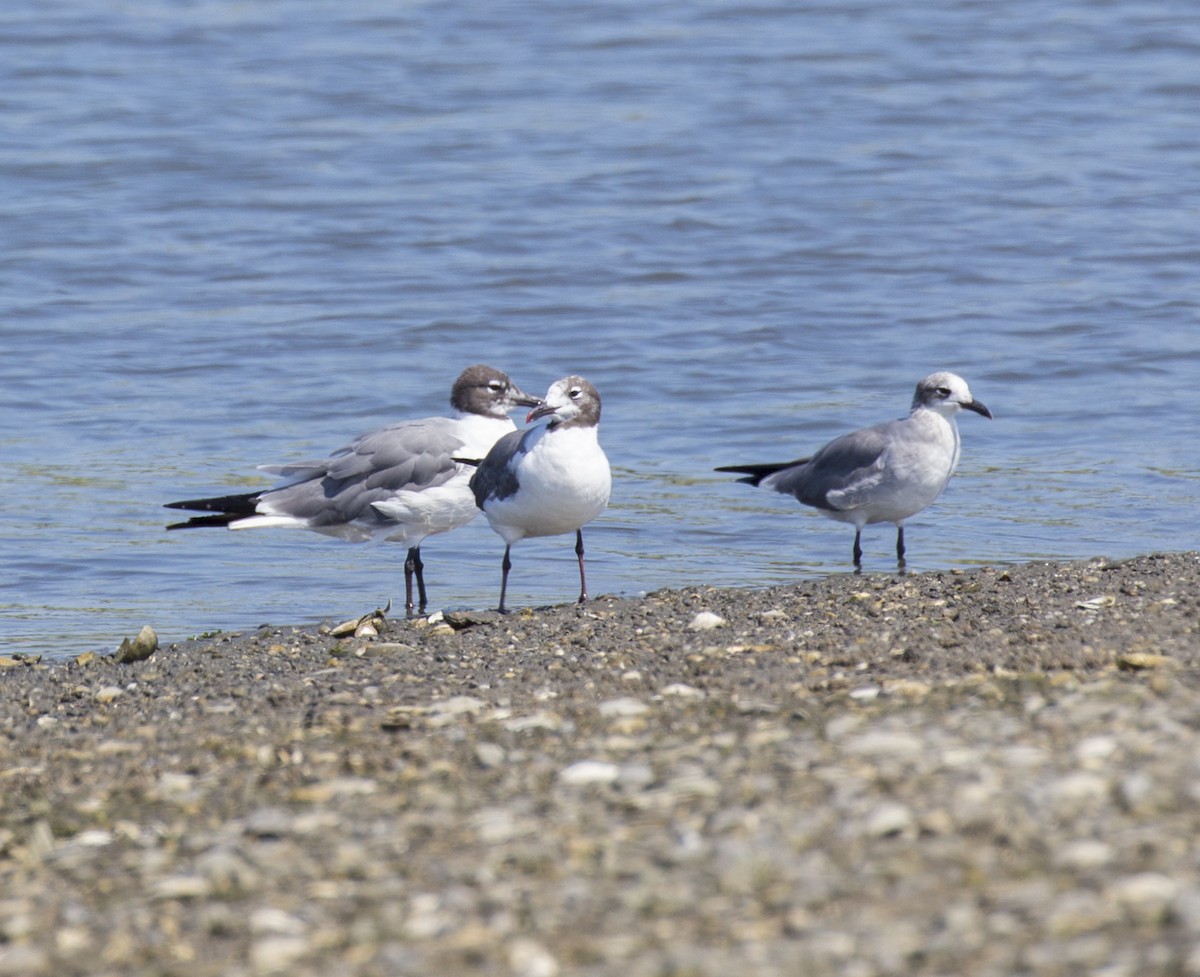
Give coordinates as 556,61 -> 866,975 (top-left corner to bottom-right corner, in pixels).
716,373 -> 991,569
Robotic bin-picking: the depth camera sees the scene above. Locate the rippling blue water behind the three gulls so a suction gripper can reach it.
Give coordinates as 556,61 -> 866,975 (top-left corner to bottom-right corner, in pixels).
0,0 -> 1200,654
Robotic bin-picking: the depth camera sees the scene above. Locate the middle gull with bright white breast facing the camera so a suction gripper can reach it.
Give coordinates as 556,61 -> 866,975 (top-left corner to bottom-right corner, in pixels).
470,377 -> 612,613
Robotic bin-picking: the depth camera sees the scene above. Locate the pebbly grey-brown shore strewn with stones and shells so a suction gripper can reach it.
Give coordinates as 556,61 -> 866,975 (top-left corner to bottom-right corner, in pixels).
0,555 -> 1200,977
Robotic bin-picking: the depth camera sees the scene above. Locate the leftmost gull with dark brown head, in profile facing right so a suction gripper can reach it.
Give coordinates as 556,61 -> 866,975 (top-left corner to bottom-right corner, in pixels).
167,365 -> 541,615
